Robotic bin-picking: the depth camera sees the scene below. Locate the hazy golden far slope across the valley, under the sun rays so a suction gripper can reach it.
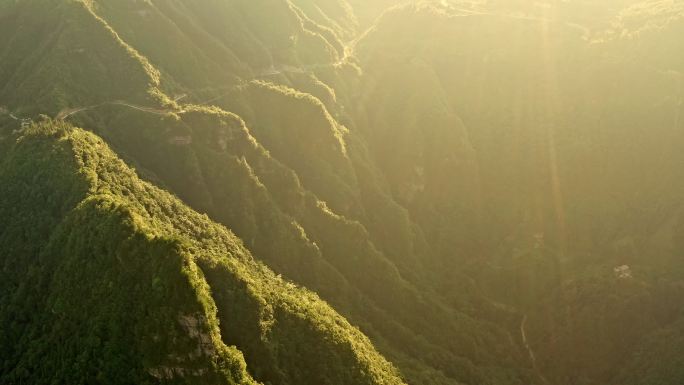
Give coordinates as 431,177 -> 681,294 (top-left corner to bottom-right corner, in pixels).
356,1 -> 684,384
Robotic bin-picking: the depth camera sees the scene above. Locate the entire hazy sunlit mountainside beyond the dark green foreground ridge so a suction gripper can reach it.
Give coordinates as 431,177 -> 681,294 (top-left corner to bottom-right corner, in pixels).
0,0 -> 684,385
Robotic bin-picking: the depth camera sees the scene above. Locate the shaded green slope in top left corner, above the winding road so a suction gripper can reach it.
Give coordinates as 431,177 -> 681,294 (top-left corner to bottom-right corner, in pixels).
0,1 -> 159,115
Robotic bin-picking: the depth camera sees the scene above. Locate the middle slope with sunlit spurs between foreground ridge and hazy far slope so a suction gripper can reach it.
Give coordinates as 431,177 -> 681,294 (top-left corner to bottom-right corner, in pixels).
1,2 -> 530,384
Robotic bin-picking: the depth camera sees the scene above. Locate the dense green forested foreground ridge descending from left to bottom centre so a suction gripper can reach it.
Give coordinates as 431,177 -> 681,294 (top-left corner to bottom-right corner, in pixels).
2,122 -> 402,384
